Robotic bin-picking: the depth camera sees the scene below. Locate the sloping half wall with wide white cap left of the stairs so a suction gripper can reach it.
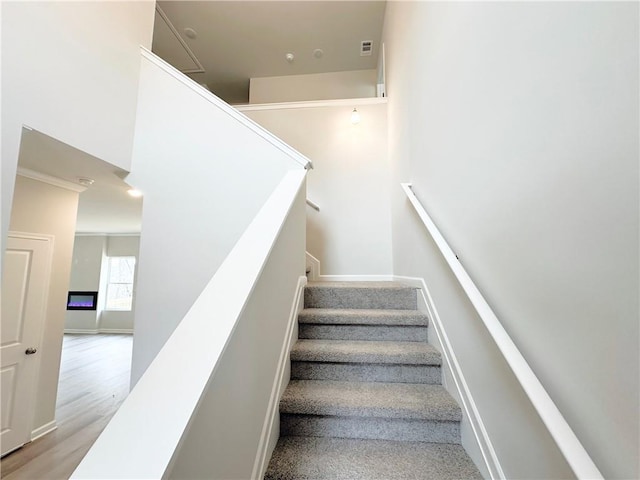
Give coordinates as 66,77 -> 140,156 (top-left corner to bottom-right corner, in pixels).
72,170 -> 306,479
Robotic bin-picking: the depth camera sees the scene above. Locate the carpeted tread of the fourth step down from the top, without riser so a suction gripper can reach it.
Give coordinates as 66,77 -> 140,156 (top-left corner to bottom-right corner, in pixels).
280,380 -> 462,421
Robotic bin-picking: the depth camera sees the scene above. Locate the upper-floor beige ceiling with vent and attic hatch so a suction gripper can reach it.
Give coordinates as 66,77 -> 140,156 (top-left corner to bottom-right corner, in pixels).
153,0 -> 386,104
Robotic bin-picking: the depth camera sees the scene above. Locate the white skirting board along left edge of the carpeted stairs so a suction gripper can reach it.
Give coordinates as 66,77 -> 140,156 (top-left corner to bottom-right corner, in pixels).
251,276 -> 307,480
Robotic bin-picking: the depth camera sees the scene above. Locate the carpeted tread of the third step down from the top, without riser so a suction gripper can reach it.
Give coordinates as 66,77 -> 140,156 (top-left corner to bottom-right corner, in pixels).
291,340 -> 441,365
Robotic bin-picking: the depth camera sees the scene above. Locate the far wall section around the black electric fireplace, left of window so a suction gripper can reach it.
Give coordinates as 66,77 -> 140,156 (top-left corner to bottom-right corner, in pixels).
64,235 -> 107,333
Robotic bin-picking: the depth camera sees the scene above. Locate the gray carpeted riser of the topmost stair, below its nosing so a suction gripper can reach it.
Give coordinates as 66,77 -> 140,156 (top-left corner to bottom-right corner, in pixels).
304,287 -> 418,310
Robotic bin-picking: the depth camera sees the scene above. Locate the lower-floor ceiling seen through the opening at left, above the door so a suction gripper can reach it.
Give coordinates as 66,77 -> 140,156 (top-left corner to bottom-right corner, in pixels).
18,128 -> 142,233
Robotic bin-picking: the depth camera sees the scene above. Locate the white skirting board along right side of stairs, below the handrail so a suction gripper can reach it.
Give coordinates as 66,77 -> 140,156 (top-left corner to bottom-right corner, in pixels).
394,276 -> 506,480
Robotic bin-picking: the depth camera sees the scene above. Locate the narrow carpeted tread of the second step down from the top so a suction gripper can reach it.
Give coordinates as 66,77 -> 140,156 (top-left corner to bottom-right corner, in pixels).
298,308 -> 429,327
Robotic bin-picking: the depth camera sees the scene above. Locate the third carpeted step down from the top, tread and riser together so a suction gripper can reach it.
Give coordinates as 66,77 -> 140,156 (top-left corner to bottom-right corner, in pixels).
291,340 -> 442,384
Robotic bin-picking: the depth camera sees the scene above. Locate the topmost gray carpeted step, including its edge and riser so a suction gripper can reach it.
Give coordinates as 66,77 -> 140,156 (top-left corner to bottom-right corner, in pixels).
304,282 -> 418,310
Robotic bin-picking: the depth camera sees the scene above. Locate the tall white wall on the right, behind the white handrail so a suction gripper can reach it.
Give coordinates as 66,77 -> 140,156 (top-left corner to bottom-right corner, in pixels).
385,2 -> 640,478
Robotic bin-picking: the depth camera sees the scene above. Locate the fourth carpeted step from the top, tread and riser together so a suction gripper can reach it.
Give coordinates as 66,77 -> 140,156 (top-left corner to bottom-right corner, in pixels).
280,380 -> 461,443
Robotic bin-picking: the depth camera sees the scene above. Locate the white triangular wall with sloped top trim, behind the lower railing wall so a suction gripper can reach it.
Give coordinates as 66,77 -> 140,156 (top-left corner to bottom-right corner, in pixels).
127,54 -> 303,383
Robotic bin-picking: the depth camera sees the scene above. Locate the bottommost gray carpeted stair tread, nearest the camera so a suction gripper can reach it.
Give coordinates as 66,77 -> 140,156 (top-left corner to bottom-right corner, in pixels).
264,437 -> 482,480
